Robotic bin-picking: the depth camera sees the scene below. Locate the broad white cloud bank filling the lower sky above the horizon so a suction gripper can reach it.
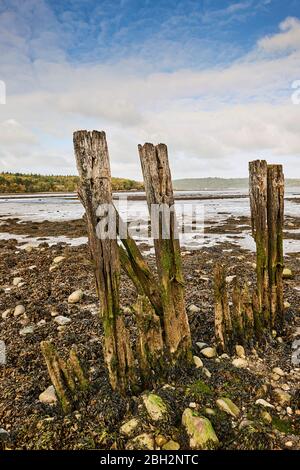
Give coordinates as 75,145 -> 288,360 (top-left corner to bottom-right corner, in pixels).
0,5 -> 300,178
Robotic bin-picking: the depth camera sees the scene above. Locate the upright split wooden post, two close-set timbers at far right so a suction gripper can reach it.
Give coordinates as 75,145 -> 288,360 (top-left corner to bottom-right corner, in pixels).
249,160 -> 284,328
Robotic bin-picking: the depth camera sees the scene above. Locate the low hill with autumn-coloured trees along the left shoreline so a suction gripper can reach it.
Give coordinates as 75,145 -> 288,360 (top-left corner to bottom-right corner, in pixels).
0,173 -> 143,194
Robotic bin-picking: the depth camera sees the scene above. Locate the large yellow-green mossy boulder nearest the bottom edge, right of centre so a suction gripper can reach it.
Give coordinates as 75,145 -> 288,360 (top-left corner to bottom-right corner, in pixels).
182,408 -> 219,450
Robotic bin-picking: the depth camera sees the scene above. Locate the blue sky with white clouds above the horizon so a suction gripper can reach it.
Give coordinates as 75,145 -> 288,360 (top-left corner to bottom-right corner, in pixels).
0,0 -> 300,180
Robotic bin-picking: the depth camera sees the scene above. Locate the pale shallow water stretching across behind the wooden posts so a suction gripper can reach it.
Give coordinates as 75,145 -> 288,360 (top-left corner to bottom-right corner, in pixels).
0,188 -> 300,253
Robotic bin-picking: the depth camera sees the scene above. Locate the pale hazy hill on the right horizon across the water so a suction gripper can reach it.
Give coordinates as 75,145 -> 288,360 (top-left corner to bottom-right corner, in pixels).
173,178 -> 300,191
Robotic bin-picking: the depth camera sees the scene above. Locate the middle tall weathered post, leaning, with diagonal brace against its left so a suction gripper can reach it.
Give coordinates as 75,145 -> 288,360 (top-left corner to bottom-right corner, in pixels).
138,143 -> 191,361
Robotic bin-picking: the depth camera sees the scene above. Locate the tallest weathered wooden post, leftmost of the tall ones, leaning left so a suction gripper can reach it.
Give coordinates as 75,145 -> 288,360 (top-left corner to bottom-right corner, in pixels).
73,131 -> 135,391
